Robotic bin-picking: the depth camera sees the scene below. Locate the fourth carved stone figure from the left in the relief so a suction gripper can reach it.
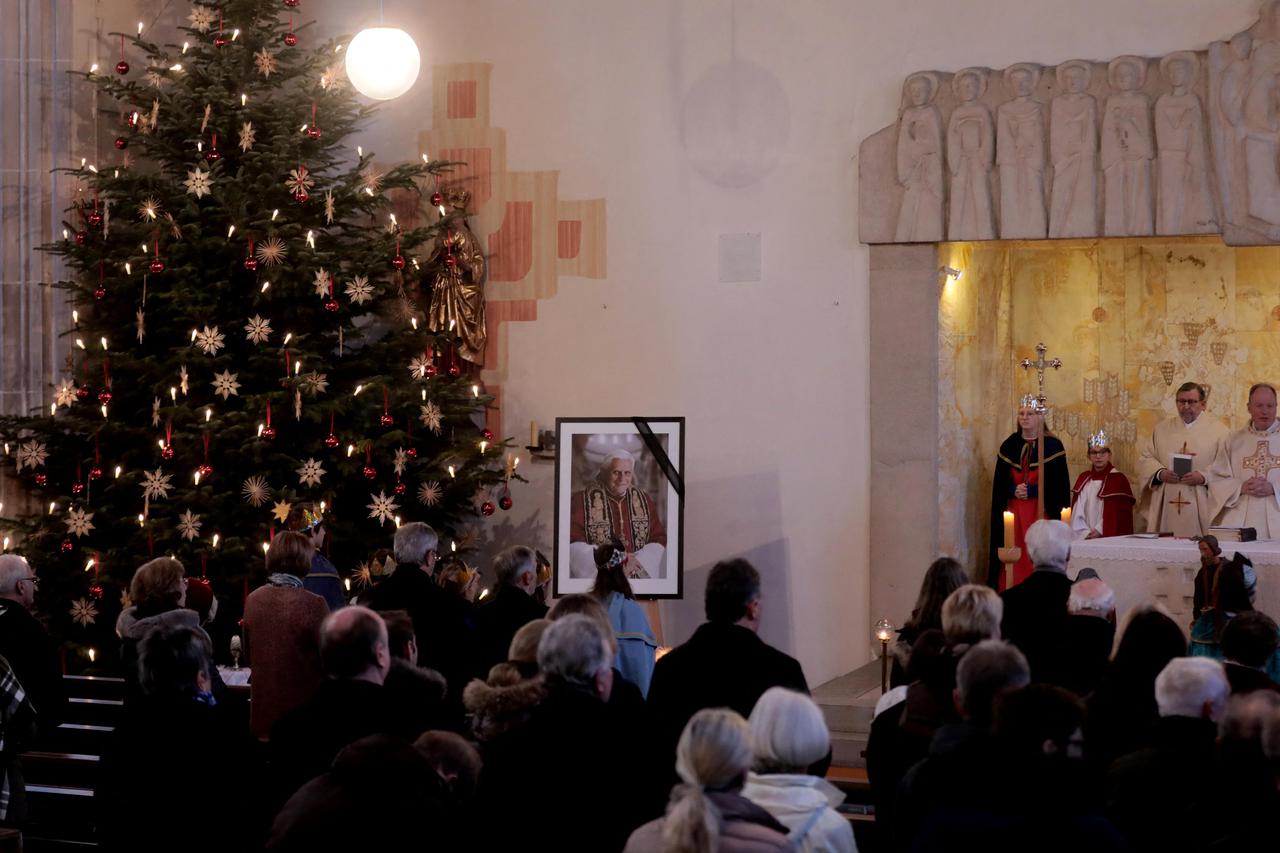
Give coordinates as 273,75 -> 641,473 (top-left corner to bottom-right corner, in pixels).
1048,59 -> 1098,237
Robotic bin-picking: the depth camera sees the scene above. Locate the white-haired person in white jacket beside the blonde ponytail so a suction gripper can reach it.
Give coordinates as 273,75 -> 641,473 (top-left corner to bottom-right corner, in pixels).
742,688 -> 858,853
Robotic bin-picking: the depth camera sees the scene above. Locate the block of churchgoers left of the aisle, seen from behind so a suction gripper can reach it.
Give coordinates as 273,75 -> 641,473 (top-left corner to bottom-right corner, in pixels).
0,514 -> 856,852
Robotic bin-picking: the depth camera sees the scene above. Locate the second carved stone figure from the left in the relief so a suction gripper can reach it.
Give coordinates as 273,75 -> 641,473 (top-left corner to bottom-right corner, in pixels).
947,68 -> 996,240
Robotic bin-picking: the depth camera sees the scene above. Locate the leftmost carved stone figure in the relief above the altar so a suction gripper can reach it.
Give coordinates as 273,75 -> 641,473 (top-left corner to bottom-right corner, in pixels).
895,72 -> 945,243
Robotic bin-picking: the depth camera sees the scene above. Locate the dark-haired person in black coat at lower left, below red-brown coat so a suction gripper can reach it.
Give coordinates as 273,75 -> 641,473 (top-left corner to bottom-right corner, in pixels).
93,625 -> 261,853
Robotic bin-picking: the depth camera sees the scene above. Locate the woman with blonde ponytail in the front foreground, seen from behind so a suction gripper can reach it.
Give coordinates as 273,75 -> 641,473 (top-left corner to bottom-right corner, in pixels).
623,708 -> 794,853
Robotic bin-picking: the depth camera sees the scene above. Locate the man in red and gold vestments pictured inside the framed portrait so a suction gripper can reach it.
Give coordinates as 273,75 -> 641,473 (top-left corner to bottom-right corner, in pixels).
568,448 -> 667,578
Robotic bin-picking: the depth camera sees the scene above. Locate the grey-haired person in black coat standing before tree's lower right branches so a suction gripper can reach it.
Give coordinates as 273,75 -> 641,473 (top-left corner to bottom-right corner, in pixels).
360,521 -> 473,695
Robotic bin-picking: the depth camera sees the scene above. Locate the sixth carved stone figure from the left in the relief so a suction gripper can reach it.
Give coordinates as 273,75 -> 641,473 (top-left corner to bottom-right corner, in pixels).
1156,50 -> 1217,234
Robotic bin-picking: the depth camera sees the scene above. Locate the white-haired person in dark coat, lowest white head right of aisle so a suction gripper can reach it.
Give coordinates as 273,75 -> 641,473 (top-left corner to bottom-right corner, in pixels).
1106,657 -> 1230,852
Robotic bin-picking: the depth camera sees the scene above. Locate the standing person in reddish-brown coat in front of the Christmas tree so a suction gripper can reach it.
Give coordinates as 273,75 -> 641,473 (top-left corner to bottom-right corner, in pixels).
244,530 -> 329,738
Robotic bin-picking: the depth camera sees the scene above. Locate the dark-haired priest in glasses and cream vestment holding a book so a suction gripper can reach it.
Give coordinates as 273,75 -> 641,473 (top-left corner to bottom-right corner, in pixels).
1138,382 -> 1230,538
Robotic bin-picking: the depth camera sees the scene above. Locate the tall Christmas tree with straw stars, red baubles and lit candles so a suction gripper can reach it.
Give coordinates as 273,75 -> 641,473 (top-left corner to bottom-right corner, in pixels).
0,0 -> 511,647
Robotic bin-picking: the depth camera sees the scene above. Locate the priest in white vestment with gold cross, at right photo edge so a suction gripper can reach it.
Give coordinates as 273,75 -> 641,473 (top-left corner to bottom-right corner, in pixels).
1211,384 -> 1280,539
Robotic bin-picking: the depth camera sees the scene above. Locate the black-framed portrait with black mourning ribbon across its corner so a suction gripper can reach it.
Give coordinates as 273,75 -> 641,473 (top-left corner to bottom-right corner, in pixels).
553,418 -> 685,598
